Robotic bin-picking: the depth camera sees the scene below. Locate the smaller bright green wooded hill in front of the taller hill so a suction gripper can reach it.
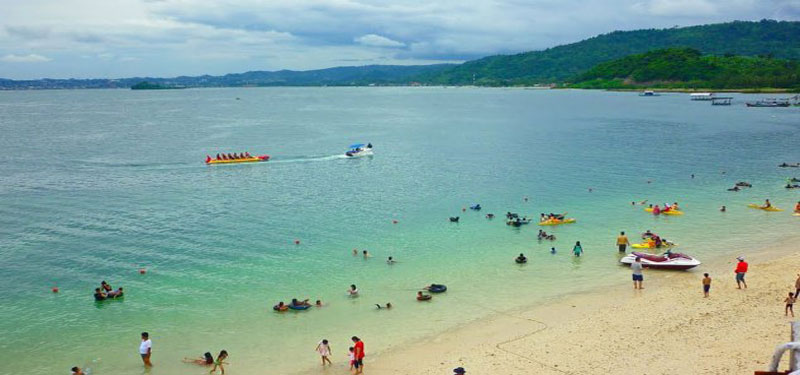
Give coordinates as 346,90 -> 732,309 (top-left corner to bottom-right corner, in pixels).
569,48 -> 800,89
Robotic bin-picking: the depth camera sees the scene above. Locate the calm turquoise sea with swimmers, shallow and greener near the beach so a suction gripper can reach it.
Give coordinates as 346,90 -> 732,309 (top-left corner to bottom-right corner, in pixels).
0,88 -> 800,374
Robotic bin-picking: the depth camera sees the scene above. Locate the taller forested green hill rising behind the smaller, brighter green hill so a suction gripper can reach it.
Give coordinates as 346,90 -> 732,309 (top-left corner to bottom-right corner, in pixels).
421,20 -> 800,85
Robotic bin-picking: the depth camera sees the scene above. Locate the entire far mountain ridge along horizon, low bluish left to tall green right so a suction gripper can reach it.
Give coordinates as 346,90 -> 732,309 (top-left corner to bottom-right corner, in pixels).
0,20 -> 800,90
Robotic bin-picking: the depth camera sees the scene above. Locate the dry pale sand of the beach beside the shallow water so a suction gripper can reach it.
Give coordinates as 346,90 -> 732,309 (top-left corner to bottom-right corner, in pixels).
364,245 -> 800,375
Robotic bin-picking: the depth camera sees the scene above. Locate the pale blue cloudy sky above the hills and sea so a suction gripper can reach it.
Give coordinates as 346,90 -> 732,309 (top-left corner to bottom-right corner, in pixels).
0,0 -> 800,79
